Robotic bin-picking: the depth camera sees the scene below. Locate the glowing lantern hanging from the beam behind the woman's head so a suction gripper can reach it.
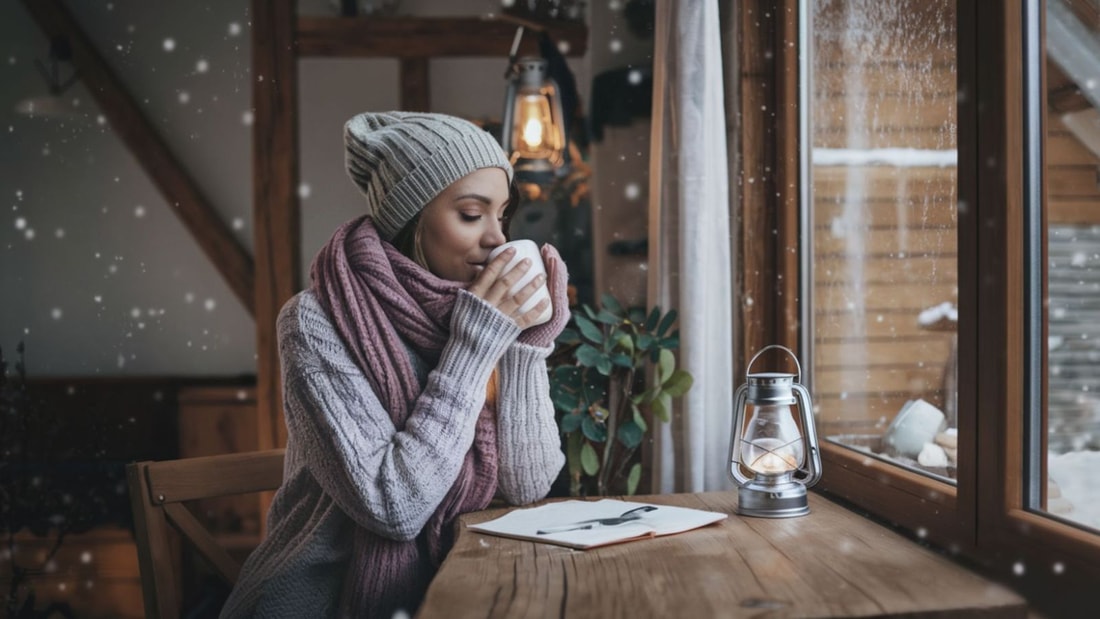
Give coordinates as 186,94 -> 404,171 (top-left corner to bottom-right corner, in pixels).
501,57 -> 565,183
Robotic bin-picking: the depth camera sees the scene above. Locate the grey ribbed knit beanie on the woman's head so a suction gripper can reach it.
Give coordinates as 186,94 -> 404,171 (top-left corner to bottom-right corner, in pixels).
344,112 -> 512,241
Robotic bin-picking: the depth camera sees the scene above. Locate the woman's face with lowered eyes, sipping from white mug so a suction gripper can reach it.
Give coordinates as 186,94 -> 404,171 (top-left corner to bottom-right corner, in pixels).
420,167 -> 508,281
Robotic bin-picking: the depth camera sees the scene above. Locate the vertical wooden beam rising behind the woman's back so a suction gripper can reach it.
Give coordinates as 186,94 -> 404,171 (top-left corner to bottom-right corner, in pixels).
251,0 -> 300,450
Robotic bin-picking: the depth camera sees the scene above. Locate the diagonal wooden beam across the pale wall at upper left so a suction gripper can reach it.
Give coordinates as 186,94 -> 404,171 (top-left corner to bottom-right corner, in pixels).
23,0 -> 255,313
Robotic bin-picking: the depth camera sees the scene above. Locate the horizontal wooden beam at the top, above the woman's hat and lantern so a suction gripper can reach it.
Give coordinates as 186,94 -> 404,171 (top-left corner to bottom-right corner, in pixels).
296,16 -> 589,58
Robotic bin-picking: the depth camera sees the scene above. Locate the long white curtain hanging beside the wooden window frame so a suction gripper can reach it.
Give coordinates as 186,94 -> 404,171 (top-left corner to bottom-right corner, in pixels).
648,0 -> 735,493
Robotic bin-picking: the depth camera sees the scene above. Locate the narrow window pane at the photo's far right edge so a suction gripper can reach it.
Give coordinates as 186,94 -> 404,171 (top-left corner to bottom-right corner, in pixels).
1033,0 -> 1100,529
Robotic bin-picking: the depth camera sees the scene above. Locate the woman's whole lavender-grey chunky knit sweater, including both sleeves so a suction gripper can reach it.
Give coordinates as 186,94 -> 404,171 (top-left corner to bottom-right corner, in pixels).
221,290 -> 564,618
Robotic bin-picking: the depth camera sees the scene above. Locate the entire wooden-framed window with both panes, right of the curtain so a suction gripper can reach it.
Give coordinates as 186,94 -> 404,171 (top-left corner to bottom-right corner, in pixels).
740,0 -> 1100,614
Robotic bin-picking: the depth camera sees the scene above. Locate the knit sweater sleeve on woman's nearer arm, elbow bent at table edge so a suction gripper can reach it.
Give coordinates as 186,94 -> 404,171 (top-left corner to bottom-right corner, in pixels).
278,291 -> 519,540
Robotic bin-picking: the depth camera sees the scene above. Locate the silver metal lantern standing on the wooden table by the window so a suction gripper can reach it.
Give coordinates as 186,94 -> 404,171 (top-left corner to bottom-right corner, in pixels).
729,344 -> 822,518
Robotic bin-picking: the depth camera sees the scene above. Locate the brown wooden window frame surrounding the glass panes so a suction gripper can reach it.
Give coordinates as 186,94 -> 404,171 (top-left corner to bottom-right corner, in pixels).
740,0 -> 1100,611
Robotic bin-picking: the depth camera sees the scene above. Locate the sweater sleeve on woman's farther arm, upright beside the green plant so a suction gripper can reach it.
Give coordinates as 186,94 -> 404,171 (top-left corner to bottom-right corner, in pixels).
497,342 -> 565,505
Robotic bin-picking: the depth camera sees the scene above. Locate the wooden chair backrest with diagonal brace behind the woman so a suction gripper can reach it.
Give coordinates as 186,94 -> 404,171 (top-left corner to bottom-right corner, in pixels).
127,450 -> 285,619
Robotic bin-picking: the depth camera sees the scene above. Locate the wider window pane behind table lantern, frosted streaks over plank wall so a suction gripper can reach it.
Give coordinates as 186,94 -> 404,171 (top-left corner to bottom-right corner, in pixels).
807,0 -> 958,480
